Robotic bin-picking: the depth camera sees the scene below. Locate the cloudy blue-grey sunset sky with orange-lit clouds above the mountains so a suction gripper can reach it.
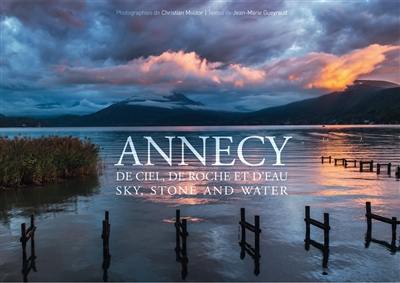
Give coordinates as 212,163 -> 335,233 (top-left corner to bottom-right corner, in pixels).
0,0 -> 400,116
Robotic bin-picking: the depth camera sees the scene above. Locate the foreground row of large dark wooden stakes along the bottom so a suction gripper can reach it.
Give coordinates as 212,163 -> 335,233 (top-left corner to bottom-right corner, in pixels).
20,202 -> 400,282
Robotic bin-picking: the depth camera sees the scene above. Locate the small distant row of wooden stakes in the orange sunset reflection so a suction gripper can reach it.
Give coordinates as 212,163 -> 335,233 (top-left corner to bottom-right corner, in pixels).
321,156 -> 400,179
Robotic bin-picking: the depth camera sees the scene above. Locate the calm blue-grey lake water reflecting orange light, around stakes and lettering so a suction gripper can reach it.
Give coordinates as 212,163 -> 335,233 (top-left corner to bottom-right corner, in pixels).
0,126 -> 400,281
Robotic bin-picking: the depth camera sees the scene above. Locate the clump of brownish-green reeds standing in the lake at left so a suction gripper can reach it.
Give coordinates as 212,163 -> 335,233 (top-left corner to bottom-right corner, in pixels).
0,136 -> 99,190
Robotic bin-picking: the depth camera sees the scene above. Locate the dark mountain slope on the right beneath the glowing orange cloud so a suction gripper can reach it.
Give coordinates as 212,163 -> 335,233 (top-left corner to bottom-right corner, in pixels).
246,81 -> 400,124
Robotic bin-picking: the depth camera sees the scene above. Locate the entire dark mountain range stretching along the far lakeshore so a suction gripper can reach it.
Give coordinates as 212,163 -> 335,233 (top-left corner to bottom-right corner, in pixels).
0,80 -> 400,127
